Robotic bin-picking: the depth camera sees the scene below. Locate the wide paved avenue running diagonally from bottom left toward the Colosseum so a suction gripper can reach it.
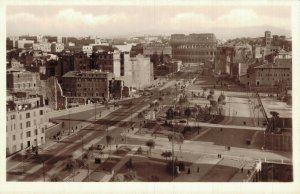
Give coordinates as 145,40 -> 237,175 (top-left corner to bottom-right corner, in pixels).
7,71 -> 190,181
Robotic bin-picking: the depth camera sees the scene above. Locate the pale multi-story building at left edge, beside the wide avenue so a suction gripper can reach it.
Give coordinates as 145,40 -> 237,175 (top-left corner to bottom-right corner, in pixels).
6,95 -> 46,155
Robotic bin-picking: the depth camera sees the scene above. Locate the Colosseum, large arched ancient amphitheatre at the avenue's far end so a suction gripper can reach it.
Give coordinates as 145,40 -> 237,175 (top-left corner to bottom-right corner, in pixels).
171,33 -> 217,63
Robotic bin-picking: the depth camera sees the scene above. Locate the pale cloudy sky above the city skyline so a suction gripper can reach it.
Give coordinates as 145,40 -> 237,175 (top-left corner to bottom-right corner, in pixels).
6,5 -> 291,39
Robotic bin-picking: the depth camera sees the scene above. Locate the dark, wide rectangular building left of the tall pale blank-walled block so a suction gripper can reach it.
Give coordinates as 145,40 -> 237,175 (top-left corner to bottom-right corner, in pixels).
62,70 -> 113,99
